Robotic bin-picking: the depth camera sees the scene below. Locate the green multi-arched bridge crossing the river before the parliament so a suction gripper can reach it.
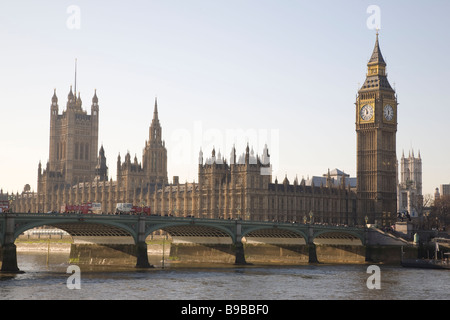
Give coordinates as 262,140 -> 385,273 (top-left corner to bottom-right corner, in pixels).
0,213 -> 408,272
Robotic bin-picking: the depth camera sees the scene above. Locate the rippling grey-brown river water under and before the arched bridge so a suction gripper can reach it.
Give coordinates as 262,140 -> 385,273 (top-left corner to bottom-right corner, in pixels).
0,252 -> 450,300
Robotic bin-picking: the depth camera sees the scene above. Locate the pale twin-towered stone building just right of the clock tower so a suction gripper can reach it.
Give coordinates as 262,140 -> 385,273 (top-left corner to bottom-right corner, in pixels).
397,150 -> 423,218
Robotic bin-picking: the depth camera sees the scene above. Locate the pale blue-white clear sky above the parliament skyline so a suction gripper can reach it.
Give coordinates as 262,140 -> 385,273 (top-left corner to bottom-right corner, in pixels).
0,0 -> 450,194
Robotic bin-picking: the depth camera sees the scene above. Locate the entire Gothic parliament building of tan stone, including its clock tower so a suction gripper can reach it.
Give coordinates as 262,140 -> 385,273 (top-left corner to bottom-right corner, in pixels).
13,34 -> 397,225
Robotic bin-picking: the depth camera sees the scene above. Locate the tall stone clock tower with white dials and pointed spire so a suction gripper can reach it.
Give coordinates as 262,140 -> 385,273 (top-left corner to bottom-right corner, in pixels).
355,32 -> 397,225
